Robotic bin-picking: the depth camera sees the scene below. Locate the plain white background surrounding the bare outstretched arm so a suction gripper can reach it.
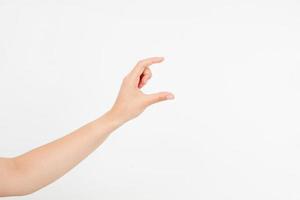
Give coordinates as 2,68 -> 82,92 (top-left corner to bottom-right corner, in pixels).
0,0 -> 300,200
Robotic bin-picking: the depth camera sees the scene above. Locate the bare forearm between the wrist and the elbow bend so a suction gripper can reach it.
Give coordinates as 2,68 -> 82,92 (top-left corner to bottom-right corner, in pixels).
4,112 -> 122,195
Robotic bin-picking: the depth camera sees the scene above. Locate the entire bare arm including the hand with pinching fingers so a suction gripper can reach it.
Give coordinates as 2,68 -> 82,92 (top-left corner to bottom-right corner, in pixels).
0,57 -> 174,197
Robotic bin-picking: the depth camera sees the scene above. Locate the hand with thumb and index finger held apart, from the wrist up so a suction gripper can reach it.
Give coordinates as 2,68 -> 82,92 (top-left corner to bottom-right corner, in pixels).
109,57 -> 174,123
